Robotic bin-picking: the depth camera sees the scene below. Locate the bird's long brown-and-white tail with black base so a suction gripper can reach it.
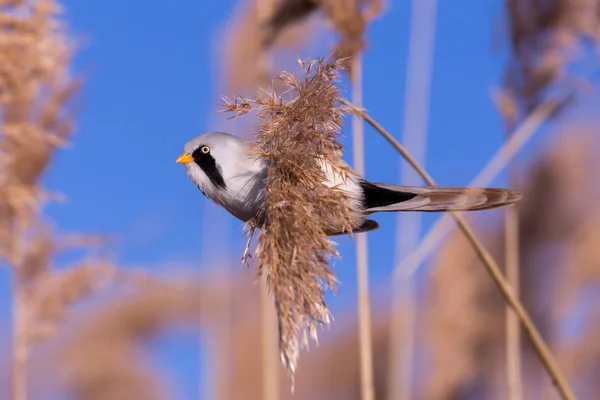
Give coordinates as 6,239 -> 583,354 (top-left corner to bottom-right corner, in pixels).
362,182 -> 522,213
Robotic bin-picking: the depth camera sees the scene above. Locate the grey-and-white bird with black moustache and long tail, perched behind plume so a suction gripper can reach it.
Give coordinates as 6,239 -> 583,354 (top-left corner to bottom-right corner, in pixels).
176,131 -> 522,255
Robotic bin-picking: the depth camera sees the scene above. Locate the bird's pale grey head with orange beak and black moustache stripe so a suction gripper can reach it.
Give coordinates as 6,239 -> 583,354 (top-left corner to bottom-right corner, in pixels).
177,132 -> 254,197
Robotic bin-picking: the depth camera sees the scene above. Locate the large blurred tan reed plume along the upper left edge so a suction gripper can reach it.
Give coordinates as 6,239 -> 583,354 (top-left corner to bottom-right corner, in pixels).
0,0 -> 77,268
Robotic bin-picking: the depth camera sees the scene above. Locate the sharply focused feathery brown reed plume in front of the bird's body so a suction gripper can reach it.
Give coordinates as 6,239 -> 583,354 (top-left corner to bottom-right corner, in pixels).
221,59 -> 356,376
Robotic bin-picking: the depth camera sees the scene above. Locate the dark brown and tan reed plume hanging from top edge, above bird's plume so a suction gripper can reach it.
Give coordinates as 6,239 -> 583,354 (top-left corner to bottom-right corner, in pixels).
261,0 -> 383,72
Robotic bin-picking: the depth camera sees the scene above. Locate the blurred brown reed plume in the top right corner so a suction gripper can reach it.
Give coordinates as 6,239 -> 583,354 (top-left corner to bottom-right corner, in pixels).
502,0 -> 600,120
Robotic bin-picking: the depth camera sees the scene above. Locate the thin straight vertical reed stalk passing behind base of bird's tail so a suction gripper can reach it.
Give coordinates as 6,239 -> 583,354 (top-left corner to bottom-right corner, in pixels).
351,54 -> 375,400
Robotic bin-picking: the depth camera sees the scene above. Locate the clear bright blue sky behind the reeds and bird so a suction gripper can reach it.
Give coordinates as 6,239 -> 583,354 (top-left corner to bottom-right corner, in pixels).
0,0 -> 592,399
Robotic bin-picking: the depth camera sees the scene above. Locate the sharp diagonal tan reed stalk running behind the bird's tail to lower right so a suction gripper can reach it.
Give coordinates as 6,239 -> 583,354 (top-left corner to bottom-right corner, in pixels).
346,102 -> 575,400
